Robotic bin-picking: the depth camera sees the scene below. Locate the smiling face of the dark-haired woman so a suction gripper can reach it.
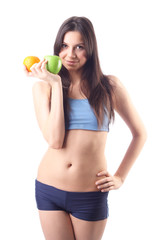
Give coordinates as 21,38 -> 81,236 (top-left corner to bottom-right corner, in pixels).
59,31 -> 87,71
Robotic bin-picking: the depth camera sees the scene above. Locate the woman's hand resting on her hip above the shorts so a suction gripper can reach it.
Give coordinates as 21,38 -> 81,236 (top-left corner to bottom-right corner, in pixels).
95,171 -> 123,192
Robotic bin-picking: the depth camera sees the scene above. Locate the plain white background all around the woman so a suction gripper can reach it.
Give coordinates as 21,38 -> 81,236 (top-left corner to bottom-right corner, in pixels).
0,0 -> 160,240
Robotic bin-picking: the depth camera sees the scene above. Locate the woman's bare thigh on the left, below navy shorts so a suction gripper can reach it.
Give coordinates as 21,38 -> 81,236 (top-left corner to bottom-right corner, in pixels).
39,210 -> 75,240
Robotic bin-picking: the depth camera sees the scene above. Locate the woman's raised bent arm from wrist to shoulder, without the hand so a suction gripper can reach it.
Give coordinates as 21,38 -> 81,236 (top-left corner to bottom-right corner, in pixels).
32,80 -> 65,149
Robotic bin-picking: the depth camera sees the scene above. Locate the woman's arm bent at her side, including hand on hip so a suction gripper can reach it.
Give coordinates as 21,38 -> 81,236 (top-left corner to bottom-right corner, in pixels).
96,76 -> 147,192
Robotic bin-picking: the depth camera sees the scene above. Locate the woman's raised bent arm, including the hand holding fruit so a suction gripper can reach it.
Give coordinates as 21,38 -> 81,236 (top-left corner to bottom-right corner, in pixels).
25,60 -> 65,149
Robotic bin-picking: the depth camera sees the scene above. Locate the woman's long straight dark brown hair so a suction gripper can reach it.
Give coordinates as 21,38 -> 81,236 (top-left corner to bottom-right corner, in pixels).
54,16 -> 114,127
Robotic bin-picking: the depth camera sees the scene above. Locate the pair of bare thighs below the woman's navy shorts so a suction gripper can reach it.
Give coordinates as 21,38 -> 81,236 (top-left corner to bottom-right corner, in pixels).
39,211 -> 107,240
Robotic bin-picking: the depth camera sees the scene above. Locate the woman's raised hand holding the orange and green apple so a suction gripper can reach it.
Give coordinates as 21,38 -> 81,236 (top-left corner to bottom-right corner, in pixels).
24,59 -> 61,85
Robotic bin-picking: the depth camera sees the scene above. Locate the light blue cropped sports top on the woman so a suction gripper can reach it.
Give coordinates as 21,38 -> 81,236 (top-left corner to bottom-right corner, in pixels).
66,98 -> 109,132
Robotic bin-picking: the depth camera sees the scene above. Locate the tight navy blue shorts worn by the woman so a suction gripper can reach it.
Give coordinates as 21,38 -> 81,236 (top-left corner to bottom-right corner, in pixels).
36,180 -> 108,221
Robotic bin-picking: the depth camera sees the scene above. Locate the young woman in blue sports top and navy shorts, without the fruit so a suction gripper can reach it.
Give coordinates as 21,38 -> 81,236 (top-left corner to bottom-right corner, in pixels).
25,17 -> 146,240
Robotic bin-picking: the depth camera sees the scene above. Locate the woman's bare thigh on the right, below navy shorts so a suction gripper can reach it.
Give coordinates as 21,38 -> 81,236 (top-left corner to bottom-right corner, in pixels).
70,214 -> 107,240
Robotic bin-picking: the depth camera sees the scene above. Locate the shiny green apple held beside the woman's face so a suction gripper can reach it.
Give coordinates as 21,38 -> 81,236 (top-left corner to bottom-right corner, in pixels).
44,55 -> 62,74
